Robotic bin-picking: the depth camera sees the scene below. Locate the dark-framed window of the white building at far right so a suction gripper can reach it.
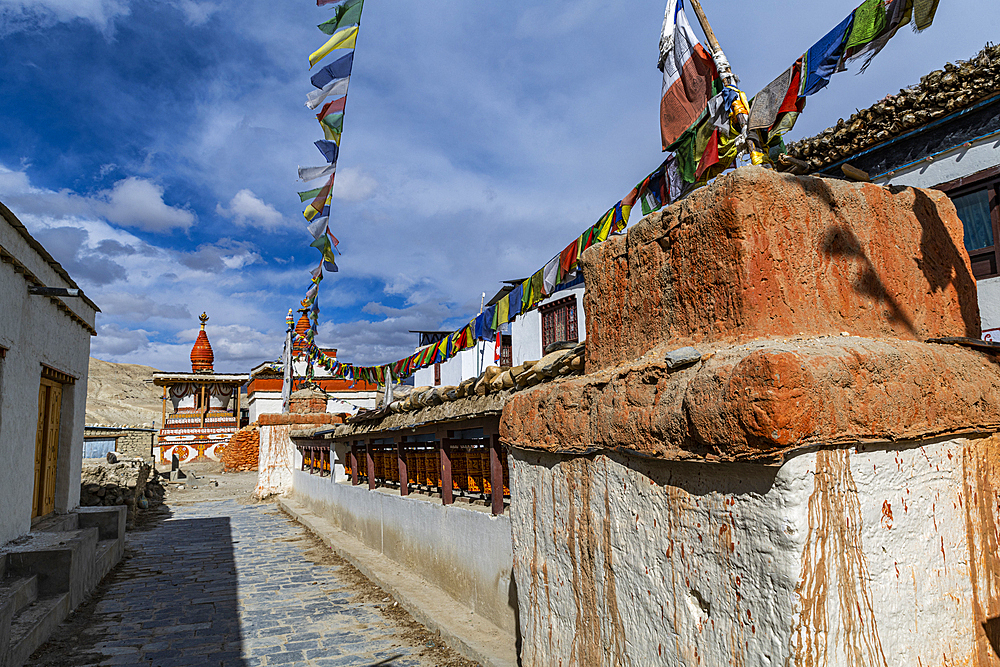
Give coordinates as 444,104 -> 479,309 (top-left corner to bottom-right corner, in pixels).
937,167 -> 1000,278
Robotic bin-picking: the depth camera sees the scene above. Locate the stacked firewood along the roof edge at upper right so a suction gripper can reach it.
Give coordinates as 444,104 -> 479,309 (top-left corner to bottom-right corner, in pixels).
787,46 -> 1000,170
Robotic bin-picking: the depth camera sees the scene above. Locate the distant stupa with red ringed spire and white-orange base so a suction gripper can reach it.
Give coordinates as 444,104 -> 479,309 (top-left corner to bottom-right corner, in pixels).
153,313 -> 249,466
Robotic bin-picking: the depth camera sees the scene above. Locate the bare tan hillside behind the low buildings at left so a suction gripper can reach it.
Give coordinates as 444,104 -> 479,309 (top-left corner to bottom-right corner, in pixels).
87,357 -> 163,426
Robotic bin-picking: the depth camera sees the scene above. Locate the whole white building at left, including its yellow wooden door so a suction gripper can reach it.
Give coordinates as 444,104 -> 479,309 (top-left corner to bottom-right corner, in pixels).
0,204 -> 98,544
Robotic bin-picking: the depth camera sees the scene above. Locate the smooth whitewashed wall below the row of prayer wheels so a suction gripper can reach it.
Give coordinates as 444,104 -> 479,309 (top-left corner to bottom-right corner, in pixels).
292,465 -> 517,634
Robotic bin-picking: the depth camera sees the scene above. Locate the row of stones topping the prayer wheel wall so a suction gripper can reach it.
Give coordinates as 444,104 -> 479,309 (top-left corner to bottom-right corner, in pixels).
358,343 -> 584,421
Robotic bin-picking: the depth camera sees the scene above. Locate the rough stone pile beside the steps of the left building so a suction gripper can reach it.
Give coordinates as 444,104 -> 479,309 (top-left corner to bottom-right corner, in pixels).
80,459 -> 164,526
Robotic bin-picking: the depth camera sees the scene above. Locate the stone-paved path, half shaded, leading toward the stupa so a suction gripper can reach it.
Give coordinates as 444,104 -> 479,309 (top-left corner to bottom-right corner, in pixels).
28,500 -> 474,667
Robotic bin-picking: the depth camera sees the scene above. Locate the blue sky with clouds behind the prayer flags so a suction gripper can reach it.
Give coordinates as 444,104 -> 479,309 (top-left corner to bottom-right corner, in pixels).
0,0 -> 1000,371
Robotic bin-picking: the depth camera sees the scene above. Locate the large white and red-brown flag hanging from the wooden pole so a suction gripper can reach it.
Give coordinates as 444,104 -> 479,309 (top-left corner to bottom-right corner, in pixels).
660,0 -> 721,150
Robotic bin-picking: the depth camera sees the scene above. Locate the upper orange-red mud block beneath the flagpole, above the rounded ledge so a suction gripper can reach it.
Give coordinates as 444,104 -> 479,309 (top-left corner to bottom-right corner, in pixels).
581,167 -> 980,372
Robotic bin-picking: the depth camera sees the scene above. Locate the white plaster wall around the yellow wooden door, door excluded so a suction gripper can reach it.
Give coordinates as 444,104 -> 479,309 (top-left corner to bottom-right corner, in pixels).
0,210 -> 96,544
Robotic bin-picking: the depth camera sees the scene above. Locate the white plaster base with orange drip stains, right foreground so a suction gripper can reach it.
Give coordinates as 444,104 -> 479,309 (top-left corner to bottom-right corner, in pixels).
511,440 -> 1000,667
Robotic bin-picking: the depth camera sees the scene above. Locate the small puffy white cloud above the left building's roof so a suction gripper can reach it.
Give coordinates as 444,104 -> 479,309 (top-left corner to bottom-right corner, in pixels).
97,176 -> 195,232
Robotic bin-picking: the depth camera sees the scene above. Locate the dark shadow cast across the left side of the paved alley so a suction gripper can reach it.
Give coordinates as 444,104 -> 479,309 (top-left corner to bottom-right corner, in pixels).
27,507 -> 248,667
